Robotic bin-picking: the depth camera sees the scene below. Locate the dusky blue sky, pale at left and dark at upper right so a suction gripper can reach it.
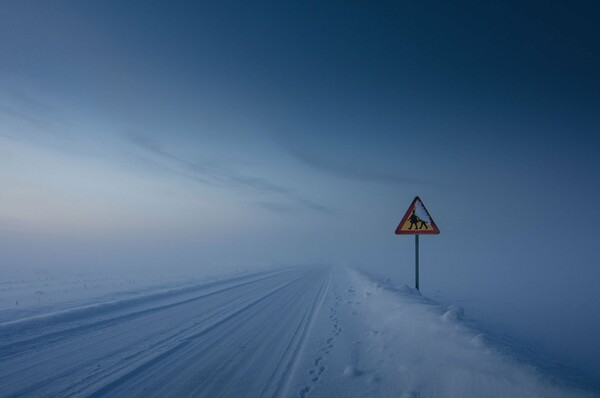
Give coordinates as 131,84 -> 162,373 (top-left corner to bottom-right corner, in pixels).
0,1 -> 600,280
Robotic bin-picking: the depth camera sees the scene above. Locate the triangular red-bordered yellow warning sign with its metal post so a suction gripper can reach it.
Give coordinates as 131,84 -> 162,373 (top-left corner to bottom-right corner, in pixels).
396,196 -> 440,290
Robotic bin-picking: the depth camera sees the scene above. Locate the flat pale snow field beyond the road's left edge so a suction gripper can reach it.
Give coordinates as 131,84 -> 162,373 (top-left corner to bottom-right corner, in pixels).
0,267 -> 255,322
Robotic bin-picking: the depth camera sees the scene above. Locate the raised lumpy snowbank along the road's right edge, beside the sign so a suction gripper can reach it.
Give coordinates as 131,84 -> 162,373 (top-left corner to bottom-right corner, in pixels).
342,271 -> 591,398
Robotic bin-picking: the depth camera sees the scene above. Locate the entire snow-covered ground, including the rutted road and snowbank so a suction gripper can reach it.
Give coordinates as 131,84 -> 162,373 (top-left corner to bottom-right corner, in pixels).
0,268 -> 595,398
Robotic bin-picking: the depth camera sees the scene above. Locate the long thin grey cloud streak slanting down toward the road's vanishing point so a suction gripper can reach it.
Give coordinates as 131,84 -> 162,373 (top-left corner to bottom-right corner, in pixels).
128,133 -> 331,213
